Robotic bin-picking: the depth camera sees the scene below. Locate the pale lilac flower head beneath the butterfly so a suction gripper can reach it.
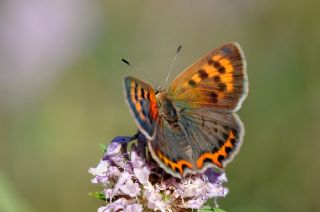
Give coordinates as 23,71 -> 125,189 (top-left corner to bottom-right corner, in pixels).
89,135 -> 228,212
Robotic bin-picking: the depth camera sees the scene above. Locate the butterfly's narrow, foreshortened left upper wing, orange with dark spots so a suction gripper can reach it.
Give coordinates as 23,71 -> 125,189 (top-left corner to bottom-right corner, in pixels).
124,77 -> 158,140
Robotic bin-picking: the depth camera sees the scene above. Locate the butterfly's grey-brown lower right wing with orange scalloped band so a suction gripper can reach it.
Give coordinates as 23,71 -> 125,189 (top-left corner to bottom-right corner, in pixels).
180,108 -> 244,172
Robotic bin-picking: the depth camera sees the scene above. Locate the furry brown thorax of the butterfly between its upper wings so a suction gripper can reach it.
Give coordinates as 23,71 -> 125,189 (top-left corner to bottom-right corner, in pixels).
156,90 -> 178,125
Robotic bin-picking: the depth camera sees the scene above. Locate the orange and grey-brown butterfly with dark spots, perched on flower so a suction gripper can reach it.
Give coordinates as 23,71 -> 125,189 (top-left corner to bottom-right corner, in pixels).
124,43 -> 248,178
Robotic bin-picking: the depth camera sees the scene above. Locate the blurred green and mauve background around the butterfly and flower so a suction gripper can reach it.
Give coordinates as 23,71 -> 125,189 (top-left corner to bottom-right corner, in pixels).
0,0 -> 320,212
